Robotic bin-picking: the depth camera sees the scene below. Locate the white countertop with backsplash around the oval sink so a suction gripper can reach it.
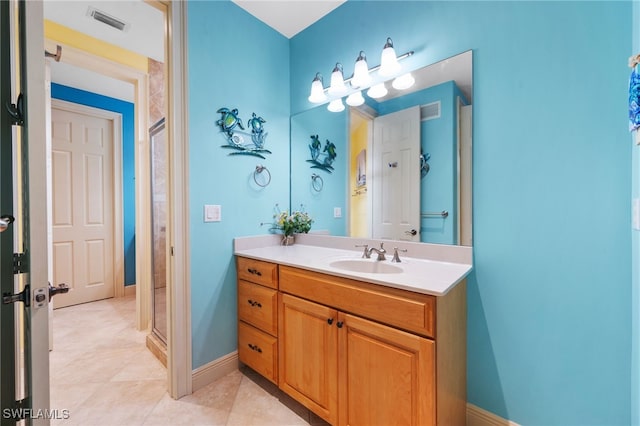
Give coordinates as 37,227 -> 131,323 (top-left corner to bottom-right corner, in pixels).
234,234 -> 472,296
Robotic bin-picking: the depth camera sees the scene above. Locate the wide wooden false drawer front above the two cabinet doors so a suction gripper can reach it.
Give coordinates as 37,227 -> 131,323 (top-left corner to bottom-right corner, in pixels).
279,266 -> 436,337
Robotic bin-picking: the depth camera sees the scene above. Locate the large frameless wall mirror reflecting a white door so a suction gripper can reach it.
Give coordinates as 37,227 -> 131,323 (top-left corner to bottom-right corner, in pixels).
290,51 -> 473,245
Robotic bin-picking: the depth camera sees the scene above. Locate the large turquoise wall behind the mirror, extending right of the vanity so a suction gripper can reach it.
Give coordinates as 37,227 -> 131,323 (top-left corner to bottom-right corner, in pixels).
290,1 -> 638,425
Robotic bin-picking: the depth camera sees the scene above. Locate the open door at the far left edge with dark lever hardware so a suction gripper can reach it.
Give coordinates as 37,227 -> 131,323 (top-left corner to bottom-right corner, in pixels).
0,0 -> 52,426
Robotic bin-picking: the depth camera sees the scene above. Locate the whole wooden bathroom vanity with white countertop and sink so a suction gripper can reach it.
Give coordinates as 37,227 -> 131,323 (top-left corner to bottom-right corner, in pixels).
235,236 -> 471,425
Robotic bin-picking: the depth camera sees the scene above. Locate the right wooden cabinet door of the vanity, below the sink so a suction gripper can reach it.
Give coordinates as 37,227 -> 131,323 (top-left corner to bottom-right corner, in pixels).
338,313 -> 436,426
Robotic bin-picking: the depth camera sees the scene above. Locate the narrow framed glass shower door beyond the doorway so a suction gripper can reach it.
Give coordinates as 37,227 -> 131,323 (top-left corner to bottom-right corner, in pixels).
149,118 -> 168,345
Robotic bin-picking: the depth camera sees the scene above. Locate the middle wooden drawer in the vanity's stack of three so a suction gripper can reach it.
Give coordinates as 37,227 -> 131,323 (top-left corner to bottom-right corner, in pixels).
238,280 -> 278,336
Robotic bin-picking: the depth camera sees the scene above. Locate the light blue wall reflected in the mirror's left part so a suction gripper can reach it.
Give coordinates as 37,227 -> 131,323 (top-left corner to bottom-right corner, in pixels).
291,105 -> 349,235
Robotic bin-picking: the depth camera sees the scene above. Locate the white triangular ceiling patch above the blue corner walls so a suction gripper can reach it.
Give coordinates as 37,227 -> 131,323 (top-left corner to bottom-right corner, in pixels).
232,0 -> 346,38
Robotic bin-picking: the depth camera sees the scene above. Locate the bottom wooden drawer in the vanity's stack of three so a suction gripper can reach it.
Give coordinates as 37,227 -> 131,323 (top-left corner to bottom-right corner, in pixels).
238,321 -> 278,384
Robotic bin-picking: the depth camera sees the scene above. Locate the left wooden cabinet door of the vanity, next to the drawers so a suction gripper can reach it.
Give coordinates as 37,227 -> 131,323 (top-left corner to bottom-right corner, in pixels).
278,293 -> 338,425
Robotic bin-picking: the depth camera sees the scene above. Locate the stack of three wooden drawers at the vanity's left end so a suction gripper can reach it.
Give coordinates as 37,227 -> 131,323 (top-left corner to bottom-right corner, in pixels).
237,257 -> 278,384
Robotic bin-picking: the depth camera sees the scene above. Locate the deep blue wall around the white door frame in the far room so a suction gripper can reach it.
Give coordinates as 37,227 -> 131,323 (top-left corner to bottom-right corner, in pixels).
51,83 -> 136,285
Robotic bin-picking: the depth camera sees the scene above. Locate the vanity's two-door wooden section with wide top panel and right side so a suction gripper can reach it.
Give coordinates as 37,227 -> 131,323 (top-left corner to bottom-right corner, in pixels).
239,256 -> 466,426
